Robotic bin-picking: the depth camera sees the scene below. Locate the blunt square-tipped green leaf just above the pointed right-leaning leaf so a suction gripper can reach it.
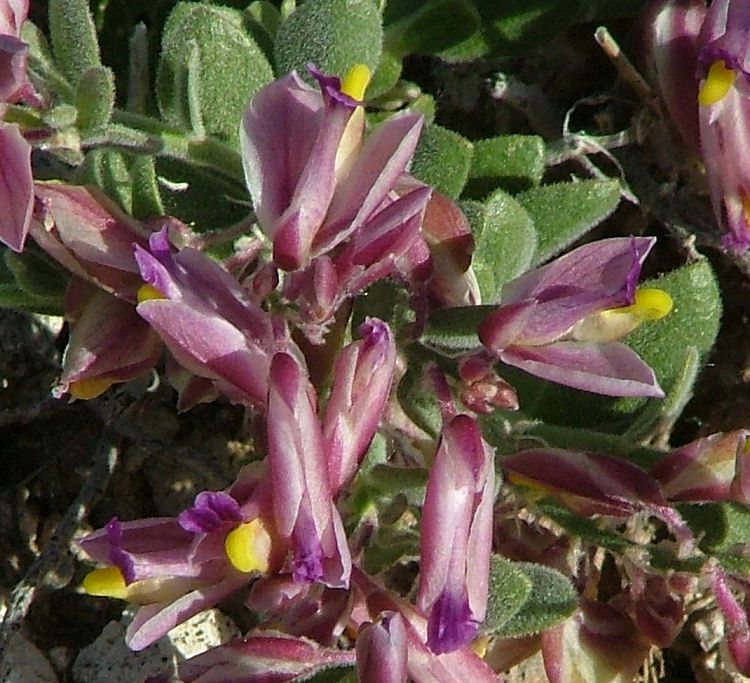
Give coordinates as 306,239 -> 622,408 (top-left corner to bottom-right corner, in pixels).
464,135 -> 544,199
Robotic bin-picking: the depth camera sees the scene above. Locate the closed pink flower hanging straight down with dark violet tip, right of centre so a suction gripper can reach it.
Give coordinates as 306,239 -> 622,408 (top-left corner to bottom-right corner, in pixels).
417,415 -> 495,653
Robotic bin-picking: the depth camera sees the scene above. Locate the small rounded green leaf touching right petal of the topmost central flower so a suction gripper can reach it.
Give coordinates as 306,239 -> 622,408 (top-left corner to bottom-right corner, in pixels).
411,123 -> 473,199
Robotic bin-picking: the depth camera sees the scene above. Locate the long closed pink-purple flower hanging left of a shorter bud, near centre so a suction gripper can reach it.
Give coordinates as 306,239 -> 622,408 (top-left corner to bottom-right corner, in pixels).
266,353 -> 351,588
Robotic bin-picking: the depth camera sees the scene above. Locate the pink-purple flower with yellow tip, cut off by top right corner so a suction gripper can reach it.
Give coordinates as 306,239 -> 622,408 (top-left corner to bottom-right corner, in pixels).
649,0 -> 750,252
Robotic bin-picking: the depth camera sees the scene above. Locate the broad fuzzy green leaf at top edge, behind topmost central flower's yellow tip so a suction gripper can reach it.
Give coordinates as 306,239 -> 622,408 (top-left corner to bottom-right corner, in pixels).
274,0 -> 383,83
